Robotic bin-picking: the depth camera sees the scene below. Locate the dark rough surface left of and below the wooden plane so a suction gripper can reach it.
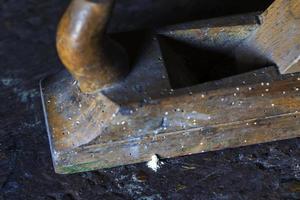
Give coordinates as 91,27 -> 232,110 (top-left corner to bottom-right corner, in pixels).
0,0 -> 300,200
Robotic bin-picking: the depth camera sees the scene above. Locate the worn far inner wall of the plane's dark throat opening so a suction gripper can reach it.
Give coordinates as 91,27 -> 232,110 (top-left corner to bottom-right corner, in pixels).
157,13 -> 260,53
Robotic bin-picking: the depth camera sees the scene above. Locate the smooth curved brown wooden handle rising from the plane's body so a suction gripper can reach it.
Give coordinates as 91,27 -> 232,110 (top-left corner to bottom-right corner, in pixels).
57,0 -> 128,93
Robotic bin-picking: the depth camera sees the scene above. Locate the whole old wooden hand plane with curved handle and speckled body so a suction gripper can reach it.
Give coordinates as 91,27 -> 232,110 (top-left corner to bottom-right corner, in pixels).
41,0 -> 300,174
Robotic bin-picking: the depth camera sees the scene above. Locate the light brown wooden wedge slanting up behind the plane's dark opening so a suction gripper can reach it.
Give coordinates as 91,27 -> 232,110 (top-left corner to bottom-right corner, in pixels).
236,0 -> 300,74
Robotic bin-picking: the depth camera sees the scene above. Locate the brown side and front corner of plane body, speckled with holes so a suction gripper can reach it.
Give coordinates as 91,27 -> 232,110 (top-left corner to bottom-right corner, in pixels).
43,67 -> 300,173
